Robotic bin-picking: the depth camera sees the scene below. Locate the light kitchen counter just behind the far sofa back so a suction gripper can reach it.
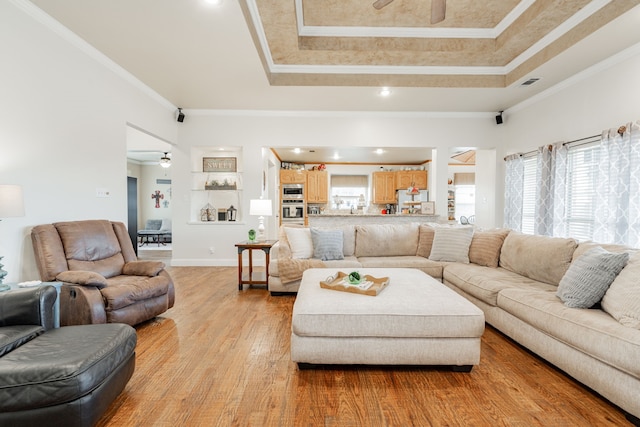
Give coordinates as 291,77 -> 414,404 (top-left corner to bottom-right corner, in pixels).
307,211 -> 442,227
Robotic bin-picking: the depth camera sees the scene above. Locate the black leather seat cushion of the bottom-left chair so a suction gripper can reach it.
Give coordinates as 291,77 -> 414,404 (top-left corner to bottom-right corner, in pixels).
0,324 -> 137,412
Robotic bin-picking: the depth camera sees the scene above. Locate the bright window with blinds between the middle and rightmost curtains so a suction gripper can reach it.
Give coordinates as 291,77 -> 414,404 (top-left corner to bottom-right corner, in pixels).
566,143 -> 600,240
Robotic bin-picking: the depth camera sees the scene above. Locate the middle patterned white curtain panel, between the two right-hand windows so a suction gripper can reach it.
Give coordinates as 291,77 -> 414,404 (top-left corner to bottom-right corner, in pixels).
534,142 -> 568,236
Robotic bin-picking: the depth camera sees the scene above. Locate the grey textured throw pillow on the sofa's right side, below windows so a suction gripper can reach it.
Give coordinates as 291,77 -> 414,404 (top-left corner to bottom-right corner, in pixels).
556,246 -> 629,308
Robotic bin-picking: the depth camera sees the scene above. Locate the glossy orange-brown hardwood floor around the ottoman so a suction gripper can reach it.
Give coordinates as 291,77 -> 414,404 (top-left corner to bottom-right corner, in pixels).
98,267 -> 630,427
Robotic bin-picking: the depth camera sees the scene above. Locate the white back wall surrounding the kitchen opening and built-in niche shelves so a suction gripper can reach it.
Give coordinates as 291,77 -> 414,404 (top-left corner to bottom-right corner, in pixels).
172,111 -> 498,265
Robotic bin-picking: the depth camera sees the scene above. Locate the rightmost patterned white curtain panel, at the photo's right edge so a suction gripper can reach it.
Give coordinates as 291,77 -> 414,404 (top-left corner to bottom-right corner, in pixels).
593,123 -> 640,247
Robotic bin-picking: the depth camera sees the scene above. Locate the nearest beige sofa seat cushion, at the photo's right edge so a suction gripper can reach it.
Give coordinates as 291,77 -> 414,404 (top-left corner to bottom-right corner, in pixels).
498,288 -> 640,377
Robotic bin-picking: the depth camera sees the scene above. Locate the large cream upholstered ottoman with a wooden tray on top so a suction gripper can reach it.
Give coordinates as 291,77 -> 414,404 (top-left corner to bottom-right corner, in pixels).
291,268 -> 484,372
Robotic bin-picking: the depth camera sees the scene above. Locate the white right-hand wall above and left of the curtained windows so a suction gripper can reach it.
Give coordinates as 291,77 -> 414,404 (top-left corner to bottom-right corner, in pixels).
496,44 -> 640,224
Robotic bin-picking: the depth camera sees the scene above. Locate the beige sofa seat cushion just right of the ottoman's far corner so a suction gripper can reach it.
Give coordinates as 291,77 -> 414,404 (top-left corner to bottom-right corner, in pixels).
442,263 -> 556,306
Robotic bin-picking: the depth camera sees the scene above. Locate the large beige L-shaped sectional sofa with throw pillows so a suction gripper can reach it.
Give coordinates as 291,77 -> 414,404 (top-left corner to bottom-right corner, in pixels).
269,223 -> 640,425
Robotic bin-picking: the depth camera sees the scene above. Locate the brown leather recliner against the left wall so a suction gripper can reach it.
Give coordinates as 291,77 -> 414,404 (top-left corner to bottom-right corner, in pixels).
31,220 -> 175,326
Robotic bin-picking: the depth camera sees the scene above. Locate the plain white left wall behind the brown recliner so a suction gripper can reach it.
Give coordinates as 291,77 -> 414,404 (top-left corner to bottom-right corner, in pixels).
0,1 -> 177,282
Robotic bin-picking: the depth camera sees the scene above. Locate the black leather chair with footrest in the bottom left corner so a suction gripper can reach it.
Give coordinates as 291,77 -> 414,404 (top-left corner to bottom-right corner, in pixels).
0,286 -> 137,427
